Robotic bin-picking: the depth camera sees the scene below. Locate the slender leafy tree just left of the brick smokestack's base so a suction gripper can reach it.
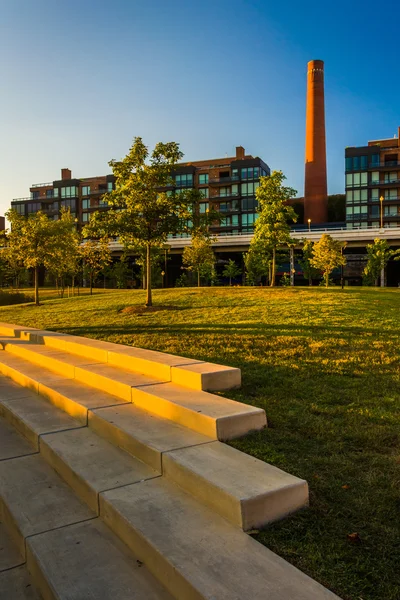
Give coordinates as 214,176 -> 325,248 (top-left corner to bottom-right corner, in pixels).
250,171 -> 297,286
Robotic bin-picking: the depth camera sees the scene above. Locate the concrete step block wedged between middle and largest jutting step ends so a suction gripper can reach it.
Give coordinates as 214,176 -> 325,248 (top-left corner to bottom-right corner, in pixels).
89,404 -> 212,473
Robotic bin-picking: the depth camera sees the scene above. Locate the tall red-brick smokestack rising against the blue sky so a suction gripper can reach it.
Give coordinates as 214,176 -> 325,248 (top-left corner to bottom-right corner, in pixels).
304,60 -> 328,223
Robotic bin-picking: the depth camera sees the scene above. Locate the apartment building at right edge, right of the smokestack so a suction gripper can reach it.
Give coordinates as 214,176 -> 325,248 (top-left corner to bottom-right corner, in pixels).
345,127 -> 400,229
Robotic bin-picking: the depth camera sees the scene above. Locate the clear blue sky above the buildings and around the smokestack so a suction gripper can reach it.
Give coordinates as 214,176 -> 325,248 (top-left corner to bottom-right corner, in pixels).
0,0 -> 400,214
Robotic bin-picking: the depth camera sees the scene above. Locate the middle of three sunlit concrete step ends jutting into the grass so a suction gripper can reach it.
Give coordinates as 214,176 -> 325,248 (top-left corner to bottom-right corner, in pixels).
132,383 -> 267,441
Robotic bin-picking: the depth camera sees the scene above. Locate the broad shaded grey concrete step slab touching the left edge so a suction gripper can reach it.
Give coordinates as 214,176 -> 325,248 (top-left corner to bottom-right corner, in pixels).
0,454 -> 95,557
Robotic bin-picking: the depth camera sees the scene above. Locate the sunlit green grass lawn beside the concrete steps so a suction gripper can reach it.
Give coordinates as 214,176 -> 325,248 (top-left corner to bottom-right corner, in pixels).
0,288 -> 400,600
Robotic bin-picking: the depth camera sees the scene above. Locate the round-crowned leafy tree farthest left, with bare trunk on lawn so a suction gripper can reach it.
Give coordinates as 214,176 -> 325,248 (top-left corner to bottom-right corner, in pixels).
6,209 -> 75,306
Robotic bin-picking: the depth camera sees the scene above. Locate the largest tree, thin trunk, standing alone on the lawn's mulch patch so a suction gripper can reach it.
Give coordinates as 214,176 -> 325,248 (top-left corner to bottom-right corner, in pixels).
85,137 -> 190,306
